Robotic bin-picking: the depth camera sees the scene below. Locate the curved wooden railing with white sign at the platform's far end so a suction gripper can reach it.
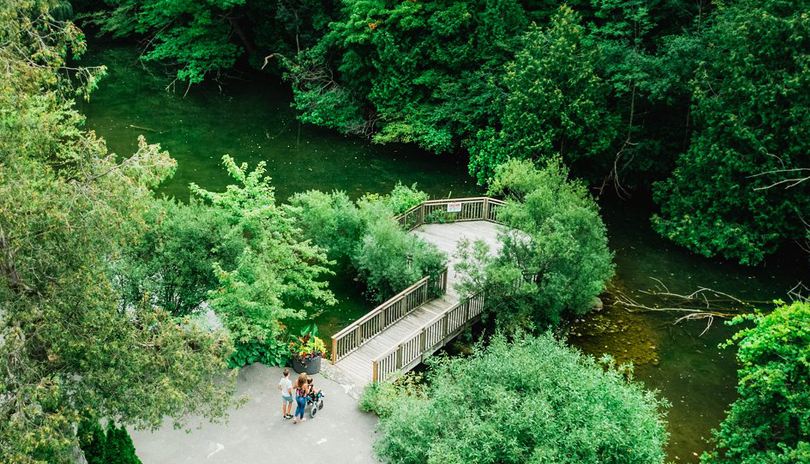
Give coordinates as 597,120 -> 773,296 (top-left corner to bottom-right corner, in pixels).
395,197 -> 504,230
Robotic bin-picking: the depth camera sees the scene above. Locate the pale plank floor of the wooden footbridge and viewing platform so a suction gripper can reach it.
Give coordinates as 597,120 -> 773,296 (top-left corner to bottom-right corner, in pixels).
336,221 -> 502,386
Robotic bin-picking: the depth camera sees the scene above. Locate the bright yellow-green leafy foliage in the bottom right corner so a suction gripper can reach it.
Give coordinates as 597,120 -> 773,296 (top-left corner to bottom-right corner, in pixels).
701,302 -> 810,464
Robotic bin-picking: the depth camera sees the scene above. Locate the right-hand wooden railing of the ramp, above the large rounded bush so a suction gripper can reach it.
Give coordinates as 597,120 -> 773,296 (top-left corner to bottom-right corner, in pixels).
371,292 -> 484,382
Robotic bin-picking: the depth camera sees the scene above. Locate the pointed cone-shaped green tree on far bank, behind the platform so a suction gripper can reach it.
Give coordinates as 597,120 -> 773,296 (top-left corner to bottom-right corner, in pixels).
470,6 -> 618,184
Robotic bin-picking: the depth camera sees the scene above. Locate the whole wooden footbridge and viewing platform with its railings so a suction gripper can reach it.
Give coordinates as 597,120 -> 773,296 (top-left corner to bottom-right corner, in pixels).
332,197 -> 504,385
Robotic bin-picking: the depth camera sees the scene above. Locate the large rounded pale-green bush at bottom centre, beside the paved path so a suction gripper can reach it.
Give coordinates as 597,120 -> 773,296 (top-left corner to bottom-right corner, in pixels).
370,334 -> 667,464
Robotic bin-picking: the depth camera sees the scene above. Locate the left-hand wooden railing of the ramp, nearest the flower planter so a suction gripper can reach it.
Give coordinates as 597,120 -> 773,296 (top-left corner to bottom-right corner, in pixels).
332,268 -> 447,364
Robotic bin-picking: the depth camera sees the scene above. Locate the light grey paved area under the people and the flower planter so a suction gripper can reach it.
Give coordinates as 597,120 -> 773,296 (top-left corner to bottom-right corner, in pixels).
130,361 -> 378,464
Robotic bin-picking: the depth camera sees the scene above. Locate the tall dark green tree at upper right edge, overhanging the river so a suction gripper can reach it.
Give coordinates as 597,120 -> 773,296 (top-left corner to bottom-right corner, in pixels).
653,0 -> 810,264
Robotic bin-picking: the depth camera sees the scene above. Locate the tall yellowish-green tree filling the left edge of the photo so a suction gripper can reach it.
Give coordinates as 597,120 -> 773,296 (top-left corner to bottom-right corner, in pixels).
0,0 -> 233,463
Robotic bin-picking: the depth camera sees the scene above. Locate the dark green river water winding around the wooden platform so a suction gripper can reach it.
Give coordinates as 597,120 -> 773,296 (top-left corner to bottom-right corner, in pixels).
81,44 -> 810,463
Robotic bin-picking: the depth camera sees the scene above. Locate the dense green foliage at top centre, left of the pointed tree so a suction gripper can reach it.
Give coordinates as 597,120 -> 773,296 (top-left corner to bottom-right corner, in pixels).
287,0 -> 528,152
